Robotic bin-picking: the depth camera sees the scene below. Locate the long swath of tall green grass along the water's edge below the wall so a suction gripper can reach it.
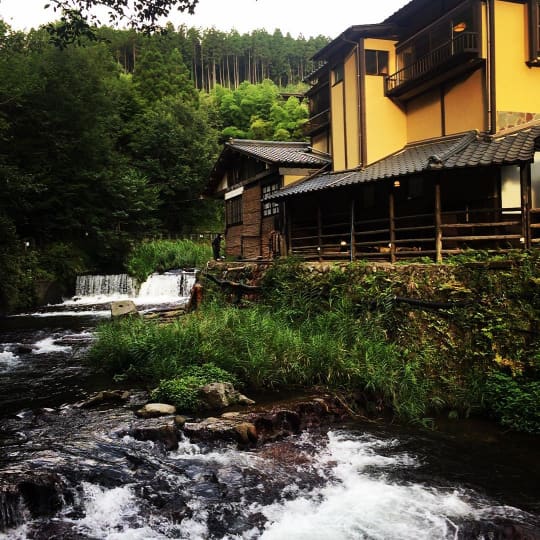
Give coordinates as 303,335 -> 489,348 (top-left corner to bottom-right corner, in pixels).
91,303 -> 432,419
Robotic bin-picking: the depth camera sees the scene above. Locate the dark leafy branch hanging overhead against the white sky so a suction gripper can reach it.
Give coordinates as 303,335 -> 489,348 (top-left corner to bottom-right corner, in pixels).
45,0 -> 199,46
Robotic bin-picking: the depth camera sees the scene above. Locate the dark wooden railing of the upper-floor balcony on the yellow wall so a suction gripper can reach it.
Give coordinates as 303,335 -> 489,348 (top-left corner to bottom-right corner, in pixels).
386,32 -> 480,94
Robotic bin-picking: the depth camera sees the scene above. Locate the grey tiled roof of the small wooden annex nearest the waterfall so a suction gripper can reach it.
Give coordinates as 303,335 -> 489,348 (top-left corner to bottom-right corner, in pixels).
225,139 -> 331,168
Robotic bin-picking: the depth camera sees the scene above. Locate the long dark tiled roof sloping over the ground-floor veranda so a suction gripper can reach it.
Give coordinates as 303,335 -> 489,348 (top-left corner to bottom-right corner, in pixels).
268,125 -> 540,199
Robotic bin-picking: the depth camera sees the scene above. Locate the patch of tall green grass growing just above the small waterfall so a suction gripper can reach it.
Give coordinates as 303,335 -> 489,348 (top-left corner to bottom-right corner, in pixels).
126,240 -> 212,283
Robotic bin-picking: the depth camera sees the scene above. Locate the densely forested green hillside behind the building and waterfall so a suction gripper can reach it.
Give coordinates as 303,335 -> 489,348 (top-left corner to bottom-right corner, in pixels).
0,21 -> 326,312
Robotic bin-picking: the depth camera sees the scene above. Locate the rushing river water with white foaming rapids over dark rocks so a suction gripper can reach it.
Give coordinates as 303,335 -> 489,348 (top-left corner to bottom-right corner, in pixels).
0,277 -> 540,540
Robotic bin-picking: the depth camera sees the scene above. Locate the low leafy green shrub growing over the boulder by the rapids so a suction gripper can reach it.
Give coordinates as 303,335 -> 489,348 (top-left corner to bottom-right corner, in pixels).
150,364 -> 237,411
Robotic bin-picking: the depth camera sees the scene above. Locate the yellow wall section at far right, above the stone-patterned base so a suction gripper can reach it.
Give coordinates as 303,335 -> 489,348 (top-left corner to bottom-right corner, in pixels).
495,0 -> 540,128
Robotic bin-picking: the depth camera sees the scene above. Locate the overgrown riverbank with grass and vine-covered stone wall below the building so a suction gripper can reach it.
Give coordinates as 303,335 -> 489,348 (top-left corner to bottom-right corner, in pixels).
91,253 -> 540,433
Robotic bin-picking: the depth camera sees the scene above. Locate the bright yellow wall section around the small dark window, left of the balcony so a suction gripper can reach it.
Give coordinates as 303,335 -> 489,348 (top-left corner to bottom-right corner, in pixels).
364,38 -> 407,164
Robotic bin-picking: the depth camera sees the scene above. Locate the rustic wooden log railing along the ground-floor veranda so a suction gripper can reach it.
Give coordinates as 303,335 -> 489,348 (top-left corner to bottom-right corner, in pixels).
288,205 -> 540,262
